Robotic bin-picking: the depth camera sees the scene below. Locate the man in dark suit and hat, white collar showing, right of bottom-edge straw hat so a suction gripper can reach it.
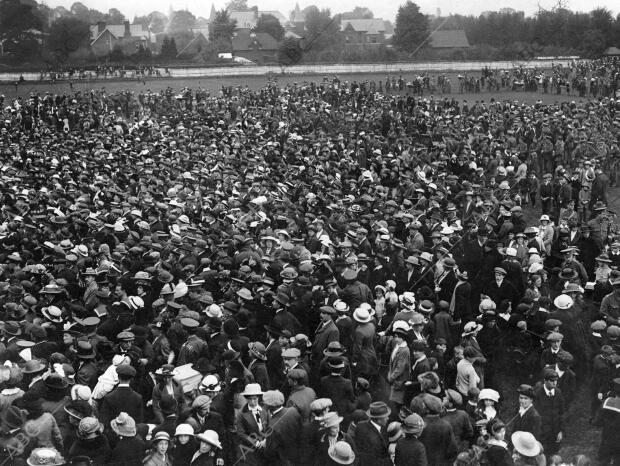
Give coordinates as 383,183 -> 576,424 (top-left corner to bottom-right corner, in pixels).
354,401 -> 391,466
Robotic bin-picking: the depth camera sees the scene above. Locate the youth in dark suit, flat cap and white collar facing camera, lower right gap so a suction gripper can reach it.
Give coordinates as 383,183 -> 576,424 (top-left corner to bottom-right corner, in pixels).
534,369 -> 565,458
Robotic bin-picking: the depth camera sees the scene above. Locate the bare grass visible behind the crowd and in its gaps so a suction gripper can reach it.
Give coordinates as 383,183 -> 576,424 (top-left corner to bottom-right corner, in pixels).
0,73 -> 608,462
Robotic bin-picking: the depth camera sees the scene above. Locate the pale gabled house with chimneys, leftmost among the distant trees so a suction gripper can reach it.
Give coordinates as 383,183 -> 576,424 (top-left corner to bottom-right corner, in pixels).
90,21 -> 155,57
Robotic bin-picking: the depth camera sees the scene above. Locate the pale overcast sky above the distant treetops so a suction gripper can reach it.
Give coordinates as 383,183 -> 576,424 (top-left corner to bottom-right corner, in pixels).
44,0 -> 620,22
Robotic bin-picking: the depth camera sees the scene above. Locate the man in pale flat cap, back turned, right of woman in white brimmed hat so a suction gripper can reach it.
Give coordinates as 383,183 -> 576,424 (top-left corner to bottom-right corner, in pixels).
263,390 -> 303,466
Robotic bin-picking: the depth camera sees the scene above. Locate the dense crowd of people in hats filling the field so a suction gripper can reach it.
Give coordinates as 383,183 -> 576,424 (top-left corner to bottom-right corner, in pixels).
0,73 -> 620,466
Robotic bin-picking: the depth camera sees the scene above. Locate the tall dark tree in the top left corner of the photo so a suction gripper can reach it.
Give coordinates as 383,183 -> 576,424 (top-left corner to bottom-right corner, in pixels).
0,0 -> 43,56
